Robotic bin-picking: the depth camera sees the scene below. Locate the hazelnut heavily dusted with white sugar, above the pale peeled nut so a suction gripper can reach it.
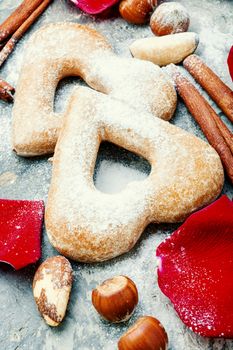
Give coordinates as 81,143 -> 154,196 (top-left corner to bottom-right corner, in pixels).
150,2 -> 189,36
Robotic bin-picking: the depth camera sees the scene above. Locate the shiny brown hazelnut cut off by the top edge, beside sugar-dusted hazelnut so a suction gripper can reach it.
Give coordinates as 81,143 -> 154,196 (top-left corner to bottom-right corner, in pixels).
119,0 -> 157,24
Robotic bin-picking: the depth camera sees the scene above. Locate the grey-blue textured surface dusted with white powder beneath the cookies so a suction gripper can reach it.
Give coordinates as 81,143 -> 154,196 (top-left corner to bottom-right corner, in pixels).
0,0 -> 233,350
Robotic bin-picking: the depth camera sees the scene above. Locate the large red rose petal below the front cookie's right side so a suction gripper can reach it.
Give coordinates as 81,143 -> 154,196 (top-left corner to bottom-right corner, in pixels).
156,196 -> 233,338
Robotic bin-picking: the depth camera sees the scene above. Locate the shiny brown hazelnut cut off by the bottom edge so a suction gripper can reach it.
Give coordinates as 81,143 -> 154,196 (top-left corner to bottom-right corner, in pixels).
118,316 -> 168,350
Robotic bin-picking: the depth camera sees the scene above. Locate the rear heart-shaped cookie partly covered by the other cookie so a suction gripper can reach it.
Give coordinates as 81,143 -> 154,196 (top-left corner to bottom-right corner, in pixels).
13,23 -> 177,156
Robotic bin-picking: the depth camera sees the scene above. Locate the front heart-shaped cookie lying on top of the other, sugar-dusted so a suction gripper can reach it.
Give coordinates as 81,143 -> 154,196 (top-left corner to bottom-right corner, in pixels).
46,88 -> 223,262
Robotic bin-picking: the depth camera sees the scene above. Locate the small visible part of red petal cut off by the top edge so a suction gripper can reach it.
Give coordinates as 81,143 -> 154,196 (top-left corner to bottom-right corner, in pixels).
71,0 -> 119,15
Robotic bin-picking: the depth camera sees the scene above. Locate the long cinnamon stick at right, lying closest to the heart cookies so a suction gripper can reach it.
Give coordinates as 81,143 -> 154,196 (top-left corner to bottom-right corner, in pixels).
172,69 -> 233,183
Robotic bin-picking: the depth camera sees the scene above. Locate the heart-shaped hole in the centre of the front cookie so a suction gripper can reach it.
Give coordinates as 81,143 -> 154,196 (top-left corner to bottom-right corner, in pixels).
93,142 -> 151,193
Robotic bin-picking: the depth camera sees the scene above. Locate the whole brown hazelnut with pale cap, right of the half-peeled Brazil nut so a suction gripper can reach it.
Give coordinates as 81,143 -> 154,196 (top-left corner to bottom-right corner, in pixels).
92,276 -> 138,322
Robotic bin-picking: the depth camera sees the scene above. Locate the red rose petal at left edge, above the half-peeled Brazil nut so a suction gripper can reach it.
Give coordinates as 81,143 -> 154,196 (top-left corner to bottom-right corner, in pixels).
0,199 -> 44,270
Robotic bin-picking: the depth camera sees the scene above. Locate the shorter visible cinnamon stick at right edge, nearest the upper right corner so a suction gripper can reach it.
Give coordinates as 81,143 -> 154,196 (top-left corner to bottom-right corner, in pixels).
183,55 -> 233,122
